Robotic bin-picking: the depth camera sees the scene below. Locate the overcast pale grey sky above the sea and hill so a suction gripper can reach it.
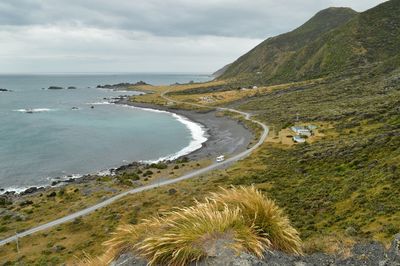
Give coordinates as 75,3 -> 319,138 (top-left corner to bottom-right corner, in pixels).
0,0 -> 384,73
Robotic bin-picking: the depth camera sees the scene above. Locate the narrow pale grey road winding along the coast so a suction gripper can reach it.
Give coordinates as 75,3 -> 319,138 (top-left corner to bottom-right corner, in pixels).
0,91 -> 268,246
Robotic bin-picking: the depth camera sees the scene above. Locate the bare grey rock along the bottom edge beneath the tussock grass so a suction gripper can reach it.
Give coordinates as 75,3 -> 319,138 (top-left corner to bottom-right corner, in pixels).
111,234 -> 400,266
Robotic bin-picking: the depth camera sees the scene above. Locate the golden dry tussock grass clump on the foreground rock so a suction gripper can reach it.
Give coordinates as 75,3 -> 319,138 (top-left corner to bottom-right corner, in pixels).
81,187 -> 302,265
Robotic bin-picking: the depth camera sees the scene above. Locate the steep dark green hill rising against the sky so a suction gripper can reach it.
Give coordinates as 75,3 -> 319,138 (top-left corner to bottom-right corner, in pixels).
220,0 -> 400,84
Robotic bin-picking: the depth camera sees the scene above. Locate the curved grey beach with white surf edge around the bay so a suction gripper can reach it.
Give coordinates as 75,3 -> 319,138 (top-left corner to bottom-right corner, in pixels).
0,96 -> 254,197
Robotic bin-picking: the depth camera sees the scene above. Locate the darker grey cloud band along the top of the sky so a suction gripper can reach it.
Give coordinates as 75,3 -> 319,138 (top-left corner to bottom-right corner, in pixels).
0,0 -> 383,38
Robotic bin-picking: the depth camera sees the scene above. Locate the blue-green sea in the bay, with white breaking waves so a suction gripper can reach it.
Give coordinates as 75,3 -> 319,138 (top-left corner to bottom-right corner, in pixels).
0,74 -> 210,191
